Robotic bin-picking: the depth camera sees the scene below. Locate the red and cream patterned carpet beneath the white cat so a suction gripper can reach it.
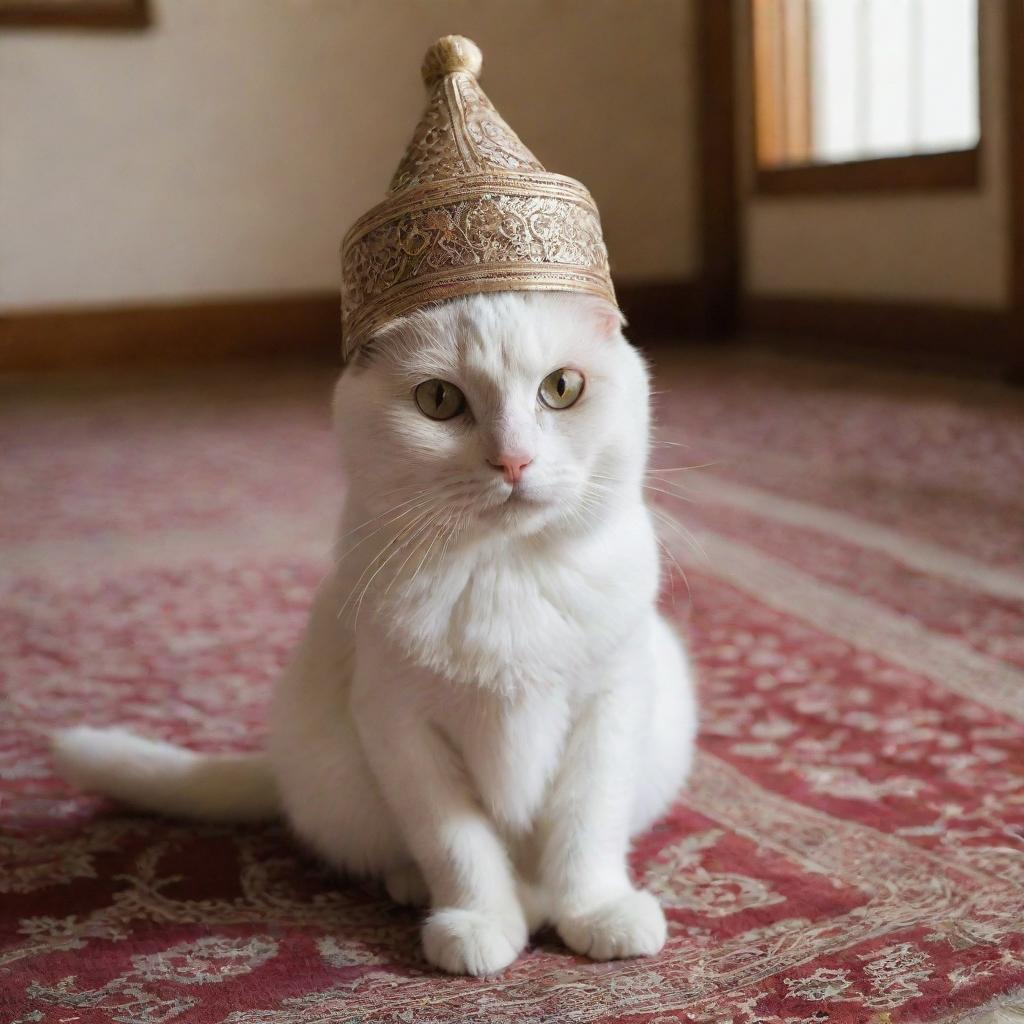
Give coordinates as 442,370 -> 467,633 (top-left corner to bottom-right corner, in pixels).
0,355 -> 1024,1024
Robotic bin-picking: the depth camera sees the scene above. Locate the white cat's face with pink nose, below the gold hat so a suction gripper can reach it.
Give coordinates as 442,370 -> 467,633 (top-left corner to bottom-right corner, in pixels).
335,293 -> 648,535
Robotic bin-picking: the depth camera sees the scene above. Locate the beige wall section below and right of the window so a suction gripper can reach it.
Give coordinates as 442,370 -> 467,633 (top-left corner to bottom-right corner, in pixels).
739,0 -> 1010,306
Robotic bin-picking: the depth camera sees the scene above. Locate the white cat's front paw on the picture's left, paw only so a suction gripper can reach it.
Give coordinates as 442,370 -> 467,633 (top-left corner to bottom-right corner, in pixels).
423,907 -> 527,977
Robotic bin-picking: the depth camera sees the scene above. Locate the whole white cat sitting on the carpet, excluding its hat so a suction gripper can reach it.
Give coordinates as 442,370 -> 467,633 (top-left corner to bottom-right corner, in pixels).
54,292 -> 696,975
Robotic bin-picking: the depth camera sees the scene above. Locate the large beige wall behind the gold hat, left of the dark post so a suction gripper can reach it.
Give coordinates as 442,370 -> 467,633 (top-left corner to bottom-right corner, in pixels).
0,0 -> 697,308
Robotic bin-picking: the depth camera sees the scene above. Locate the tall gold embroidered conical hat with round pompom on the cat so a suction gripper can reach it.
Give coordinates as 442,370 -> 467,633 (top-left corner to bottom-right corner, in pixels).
341,36 -> 615,361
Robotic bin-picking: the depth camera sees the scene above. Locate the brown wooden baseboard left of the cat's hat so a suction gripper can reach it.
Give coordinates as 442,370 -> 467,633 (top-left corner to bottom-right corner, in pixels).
0,292 -> 341,372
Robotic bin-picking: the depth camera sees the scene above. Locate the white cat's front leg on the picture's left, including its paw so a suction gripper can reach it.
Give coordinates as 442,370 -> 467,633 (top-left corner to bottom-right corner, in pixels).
353,677 -> 528,975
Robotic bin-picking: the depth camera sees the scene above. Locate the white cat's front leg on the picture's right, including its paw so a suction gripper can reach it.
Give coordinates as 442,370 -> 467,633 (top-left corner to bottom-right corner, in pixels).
541,683 -> 666,959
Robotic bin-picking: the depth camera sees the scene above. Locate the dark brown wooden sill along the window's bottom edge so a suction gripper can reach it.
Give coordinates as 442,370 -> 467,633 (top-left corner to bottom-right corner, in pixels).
754,146 -> 981,196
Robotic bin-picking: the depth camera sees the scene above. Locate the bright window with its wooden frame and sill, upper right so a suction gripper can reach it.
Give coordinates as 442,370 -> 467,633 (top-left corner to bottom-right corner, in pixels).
752,0 -> 980,191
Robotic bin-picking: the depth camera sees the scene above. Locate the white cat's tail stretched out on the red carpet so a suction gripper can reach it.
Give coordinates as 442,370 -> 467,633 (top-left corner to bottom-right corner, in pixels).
50,726 -> 281,822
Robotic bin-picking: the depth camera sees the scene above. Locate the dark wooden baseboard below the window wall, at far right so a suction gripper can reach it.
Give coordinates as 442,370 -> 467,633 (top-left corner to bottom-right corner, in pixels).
740,295 -> 1024,367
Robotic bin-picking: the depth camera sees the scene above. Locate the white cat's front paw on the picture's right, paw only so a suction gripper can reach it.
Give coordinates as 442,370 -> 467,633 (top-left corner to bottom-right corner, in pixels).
558,889 -> 667,959
